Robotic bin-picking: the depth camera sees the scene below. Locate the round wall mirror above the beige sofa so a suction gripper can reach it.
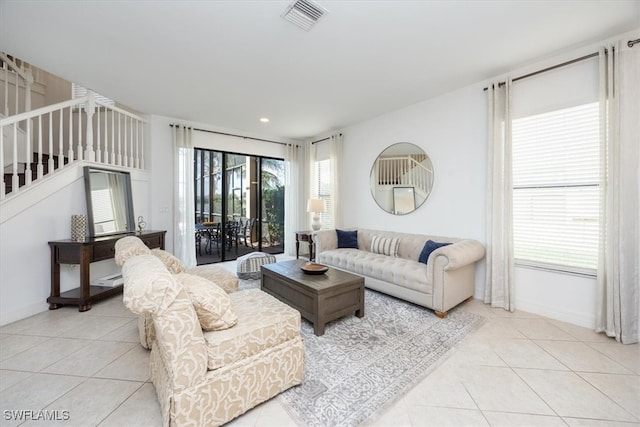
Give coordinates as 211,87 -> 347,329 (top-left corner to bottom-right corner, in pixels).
369,142 -> 433,215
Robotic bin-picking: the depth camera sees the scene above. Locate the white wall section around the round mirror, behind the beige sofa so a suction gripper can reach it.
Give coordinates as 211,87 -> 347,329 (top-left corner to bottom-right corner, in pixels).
341,84 -> 487,295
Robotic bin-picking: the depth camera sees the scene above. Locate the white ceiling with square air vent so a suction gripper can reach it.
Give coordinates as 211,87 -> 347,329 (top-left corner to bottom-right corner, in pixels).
0,0 -> 640,139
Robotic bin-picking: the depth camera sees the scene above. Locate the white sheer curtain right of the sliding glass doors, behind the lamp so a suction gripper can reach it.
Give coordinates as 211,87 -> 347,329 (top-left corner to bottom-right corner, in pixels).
284,144 -> 307,255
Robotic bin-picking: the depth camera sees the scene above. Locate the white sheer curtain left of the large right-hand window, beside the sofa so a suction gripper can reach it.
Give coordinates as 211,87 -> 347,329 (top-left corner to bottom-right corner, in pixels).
484,79 -> 515,311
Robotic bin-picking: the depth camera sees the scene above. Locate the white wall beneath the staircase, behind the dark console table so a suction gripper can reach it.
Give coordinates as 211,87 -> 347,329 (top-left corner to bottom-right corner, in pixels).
0,162 -> 149,325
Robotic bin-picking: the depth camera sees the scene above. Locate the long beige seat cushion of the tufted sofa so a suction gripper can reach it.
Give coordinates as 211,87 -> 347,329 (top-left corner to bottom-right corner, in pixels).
318,249 -> 433,294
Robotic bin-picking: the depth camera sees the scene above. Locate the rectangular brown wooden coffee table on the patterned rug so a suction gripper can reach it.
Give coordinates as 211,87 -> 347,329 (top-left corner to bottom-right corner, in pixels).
260,259 -> 364,336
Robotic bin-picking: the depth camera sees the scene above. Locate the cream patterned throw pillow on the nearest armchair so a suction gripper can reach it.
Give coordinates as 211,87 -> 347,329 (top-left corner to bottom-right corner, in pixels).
176,273 -> 238,331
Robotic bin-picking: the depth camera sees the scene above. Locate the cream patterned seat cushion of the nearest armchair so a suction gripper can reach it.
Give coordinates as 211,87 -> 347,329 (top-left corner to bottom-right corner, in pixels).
204,289 -> 300,370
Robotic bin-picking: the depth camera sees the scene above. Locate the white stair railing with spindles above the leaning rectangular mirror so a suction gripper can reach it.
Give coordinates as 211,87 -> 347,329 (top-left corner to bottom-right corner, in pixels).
0,91 -> 145,200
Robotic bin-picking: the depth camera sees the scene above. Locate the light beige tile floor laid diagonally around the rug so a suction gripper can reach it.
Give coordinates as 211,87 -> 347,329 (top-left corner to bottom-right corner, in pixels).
0,264 -> 640,427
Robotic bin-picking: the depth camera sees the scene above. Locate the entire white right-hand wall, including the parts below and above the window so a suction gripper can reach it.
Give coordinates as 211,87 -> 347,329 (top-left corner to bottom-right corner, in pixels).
342,34 -> 640,328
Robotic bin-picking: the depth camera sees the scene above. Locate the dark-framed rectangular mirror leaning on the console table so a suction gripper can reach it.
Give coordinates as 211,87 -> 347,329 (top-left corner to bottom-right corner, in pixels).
84,166 -> 135,237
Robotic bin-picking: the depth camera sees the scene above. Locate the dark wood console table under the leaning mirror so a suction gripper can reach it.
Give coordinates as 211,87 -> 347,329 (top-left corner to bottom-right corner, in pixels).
47,230 -> 166,311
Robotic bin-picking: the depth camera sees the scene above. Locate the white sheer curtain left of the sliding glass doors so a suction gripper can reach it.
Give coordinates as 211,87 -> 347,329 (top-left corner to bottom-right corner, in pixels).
173,125 -> 197,267
